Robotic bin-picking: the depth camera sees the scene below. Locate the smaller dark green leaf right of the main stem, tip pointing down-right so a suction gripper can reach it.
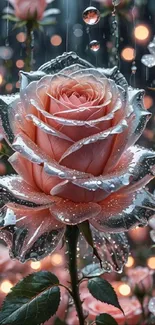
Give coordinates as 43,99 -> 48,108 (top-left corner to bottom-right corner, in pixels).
88,277 -> 123,312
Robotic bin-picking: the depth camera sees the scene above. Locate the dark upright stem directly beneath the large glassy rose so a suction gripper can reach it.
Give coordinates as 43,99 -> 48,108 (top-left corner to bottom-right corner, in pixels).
66,226 -> 85,325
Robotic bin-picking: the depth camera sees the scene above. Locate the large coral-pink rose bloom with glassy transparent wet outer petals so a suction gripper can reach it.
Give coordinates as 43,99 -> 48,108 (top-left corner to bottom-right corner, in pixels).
0,52 -> 155,270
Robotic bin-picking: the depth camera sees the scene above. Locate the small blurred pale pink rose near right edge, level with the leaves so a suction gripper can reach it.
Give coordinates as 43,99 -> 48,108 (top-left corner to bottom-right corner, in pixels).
127,266 -> 154,292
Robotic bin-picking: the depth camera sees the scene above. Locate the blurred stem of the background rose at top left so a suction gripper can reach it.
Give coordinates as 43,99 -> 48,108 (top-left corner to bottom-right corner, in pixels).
25,20 -> 34,72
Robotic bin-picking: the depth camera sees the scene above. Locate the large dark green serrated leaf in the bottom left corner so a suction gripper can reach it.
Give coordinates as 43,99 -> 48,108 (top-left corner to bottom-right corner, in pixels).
0,271 -> 60,325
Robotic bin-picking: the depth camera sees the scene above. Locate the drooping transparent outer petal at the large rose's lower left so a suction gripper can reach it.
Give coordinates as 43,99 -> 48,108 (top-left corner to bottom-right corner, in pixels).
0,204 -> 65,262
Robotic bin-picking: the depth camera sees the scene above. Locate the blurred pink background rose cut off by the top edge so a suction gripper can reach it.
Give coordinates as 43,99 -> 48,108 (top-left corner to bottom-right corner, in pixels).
9,0 -> 47,20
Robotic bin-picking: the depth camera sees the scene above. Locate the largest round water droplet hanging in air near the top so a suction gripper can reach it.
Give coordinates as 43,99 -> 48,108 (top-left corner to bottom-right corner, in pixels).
83,7 -> 100,25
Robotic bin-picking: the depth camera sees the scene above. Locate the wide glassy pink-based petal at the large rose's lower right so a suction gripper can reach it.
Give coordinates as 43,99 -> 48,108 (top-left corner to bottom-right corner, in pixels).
90,190 -> 155,233
